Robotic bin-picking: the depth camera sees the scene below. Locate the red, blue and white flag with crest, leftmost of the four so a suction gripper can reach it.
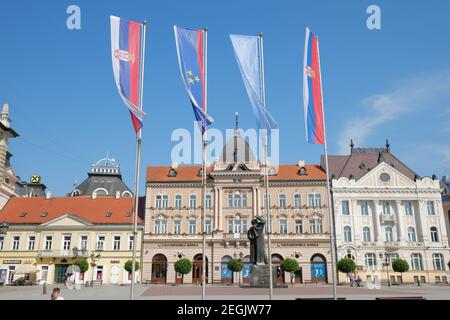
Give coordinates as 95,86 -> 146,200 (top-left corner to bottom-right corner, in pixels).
110,16 -> 145,133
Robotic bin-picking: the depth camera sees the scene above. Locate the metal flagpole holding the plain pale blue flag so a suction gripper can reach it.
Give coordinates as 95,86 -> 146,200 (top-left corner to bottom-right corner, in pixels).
259,32 -> 273,300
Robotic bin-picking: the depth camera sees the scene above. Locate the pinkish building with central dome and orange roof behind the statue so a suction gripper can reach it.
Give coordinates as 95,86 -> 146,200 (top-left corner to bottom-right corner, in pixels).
142,124 -> 331,283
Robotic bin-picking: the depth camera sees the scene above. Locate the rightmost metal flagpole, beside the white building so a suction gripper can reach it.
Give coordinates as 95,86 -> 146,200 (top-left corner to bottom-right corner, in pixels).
317,37 -> 337,300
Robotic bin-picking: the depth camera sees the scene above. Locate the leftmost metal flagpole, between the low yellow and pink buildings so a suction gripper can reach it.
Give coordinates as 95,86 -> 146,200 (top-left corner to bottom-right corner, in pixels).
130,20 -> 147,300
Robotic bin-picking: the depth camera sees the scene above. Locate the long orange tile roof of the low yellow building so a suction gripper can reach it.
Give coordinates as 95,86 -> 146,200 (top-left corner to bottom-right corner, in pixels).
0,196 -> 144,224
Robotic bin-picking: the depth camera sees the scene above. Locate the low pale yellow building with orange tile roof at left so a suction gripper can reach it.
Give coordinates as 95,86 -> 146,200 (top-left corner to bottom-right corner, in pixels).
0,193 -> 143,284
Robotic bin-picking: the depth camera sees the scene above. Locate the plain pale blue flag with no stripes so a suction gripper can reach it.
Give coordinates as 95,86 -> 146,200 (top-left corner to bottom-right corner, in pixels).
230,35 -> 278,132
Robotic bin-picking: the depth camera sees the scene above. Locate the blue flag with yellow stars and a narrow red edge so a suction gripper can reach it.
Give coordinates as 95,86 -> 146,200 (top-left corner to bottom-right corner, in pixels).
174,26 -> 214,134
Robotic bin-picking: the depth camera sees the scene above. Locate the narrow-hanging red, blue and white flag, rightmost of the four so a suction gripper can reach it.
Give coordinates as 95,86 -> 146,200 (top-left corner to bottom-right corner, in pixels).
303,28 -> 325,144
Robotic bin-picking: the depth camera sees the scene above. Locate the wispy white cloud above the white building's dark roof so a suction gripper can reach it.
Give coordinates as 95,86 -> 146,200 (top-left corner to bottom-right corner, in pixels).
337,70 -> 450,153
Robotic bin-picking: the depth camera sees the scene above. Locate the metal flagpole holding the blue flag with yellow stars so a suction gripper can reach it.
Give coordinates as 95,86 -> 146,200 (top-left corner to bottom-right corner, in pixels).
202,28 -> 208,300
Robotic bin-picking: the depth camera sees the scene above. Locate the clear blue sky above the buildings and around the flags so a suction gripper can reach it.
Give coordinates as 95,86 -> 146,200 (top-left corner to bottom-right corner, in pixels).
0,0 -> 450,195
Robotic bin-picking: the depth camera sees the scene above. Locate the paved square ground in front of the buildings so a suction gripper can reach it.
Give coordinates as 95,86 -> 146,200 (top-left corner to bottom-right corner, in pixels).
0,285 -> 450,300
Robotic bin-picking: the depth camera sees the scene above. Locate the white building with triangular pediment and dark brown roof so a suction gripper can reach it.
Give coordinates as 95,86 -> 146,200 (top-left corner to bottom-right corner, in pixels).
322,142 -> 449,283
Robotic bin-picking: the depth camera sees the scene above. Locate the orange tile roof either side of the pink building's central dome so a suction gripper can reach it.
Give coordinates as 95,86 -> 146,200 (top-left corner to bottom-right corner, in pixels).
147,164 -> 326,182
